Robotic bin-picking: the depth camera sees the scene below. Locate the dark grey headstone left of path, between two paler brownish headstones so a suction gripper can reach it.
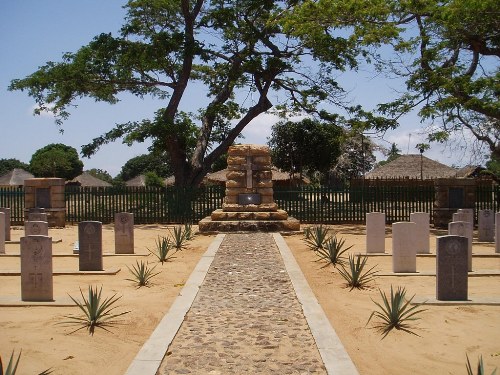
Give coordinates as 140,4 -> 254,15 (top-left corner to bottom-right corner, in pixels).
78,221 -> 103,271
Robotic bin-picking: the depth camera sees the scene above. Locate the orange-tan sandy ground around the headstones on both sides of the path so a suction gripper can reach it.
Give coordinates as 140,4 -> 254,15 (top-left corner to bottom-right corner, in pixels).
0,225 -> 500,375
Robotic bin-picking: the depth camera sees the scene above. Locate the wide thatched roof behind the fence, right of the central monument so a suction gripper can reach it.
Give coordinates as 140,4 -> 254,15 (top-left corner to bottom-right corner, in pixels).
365,154 -> 457,179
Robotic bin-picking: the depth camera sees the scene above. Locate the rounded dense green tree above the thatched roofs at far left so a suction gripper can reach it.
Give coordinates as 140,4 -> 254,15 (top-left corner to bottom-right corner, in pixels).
30,143 -> 83,180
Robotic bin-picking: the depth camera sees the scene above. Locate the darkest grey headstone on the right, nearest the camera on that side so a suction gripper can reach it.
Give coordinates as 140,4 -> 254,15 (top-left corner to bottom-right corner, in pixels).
436,236 -> 468,301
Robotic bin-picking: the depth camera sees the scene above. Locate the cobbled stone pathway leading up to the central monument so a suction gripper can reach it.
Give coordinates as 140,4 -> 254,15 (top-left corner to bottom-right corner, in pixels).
158,233 -> 326,375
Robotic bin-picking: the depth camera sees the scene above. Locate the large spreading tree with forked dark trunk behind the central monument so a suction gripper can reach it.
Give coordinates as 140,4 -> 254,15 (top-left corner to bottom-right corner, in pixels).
10,0 -> 376,185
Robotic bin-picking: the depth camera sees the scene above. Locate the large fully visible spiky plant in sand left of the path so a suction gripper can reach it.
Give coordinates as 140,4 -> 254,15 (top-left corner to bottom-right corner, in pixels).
60,286 -> 130,335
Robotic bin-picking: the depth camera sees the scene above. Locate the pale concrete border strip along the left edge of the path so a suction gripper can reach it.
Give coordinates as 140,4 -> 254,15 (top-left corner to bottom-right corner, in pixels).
125,234 -> 225,375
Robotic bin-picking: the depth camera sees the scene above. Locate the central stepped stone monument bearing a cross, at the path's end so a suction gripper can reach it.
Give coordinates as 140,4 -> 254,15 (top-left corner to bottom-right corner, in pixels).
198,144 -> 300,232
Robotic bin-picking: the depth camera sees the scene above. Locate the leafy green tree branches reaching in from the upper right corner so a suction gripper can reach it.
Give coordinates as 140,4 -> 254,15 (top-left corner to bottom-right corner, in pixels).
285,0 -> 500,158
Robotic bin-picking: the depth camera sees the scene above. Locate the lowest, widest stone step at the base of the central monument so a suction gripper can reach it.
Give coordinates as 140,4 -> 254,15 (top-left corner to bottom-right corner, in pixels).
198,216 -> 300,233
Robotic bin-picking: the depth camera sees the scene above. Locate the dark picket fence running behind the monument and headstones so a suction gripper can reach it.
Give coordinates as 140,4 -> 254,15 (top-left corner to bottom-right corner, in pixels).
0,184 -> 500,224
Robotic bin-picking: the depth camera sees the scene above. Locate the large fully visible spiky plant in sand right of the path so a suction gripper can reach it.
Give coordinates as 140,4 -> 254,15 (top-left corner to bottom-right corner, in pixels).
366,285 -> 426,339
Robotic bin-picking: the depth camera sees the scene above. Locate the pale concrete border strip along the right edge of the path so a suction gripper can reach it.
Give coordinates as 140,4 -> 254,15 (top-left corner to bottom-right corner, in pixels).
273,233 -> 359,375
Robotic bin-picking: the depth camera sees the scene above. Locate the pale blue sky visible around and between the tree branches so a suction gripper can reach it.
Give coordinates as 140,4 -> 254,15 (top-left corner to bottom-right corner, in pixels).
0,0 -> 476,176
